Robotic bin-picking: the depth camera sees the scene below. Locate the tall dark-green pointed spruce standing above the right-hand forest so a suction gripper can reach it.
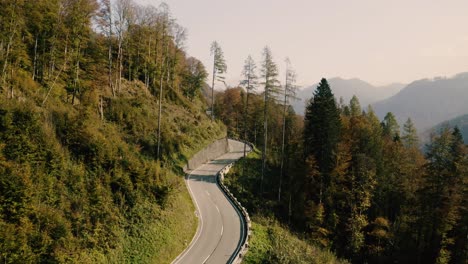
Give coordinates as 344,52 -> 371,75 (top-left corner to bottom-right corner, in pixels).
304,79 -> 342,250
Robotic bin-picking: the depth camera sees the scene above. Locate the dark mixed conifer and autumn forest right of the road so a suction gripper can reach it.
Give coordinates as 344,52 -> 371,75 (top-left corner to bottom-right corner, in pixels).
218,77 -> 468,264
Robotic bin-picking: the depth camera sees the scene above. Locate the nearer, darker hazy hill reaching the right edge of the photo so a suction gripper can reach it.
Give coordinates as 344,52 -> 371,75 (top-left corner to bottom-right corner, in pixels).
373,73 -> 468,132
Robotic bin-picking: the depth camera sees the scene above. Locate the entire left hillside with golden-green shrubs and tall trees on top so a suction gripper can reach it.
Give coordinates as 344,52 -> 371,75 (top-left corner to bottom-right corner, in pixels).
0,0 -> 225,263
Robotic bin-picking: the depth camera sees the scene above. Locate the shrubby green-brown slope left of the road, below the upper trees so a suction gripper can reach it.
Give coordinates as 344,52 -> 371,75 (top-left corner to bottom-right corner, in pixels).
0,82 -> 225,263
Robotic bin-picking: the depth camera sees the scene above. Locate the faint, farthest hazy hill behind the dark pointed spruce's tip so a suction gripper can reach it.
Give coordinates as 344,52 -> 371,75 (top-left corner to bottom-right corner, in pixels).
292,77 -> 404,114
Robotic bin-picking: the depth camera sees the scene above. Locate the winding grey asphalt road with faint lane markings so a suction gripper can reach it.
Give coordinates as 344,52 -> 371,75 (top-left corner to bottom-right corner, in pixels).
172,140 -> 250,264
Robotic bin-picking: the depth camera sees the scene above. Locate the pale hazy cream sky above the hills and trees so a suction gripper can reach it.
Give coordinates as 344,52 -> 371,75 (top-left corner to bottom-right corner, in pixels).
136,0 -> 468,88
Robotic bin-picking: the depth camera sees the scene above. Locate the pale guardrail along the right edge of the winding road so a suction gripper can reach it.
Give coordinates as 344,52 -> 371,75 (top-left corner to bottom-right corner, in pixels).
216,139 -> 253,263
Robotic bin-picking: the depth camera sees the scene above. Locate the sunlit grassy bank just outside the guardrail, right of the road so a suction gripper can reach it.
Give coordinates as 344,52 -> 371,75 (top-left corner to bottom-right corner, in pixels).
225,150 -> 348,264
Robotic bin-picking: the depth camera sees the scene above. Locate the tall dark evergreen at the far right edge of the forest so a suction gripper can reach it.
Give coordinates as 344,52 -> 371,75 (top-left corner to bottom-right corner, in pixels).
422,128 -> 468,263
